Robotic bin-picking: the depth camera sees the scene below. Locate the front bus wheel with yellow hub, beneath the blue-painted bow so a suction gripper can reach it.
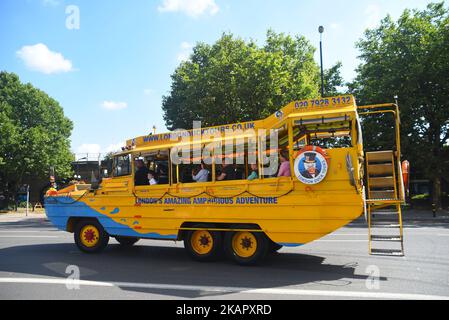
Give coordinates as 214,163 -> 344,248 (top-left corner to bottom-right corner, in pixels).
74,219 -> 109,253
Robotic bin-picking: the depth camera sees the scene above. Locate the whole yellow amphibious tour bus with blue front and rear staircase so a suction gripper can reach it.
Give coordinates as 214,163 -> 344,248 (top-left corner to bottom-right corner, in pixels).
45,95 -> 404,265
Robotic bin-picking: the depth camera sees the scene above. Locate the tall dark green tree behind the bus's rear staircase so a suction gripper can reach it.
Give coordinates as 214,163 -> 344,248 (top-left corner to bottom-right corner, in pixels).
349,3 -> 449,207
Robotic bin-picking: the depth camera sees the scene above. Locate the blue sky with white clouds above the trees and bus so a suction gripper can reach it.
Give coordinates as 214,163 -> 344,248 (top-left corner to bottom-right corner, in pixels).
0,0 -> 430,157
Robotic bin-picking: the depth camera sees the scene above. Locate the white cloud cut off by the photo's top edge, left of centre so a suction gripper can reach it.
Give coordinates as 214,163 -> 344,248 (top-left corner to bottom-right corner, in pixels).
158,0 -> 220,18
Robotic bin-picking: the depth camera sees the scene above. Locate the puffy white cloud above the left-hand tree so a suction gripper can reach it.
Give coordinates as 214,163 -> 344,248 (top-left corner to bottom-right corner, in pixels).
16,43 -> 73,74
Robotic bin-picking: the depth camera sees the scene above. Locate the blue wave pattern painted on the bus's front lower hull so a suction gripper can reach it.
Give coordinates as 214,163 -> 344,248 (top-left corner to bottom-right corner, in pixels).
45,197 -> 178,240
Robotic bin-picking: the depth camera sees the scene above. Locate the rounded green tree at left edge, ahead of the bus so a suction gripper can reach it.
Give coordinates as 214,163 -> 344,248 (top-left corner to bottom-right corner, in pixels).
0,71 -> 73,201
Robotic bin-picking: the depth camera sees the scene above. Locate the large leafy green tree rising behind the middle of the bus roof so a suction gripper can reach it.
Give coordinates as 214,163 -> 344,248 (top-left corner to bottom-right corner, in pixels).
162,30 -> 342,130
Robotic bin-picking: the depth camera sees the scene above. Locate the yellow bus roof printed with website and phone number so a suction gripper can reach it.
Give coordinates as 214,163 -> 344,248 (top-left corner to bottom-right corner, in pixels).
123,95 -> 357,151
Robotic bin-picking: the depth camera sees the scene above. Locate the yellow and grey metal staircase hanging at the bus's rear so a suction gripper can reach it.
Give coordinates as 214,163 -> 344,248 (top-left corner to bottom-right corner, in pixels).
365,150 -> 404,256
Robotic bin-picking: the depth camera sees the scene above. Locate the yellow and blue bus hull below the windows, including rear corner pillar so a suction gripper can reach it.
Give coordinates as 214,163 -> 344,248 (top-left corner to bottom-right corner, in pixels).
46,149 -> 364,246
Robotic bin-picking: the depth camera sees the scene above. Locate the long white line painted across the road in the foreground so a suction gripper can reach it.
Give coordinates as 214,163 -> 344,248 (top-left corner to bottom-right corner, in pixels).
0,278 -> 449,300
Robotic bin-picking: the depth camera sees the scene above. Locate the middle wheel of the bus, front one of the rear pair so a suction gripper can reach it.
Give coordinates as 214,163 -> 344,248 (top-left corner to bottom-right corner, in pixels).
184,226 -> 222,262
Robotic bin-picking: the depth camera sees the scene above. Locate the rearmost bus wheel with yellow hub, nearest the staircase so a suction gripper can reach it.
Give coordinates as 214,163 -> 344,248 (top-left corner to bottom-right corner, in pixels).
224,231 -> 269,265
